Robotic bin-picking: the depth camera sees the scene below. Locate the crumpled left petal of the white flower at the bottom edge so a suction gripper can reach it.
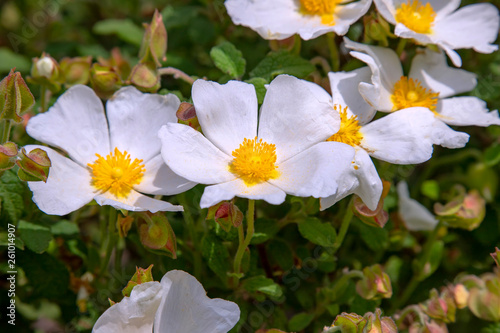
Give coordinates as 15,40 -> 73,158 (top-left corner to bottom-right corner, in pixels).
92,282 -> 163,333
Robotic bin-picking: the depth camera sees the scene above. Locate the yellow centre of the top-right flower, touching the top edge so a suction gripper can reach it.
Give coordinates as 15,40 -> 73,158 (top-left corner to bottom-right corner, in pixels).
395,0 -> 436,34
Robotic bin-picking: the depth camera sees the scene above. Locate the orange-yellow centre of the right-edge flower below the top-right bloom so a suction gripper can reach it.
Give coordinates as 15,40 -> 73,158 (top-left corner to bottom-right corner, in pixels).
391,76 -> 439,112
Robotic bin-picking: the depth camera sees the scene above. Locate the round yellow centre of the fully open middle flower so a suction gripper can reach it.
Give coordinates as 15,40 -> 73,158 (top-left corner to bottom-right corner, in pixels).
229,137 -> 279,186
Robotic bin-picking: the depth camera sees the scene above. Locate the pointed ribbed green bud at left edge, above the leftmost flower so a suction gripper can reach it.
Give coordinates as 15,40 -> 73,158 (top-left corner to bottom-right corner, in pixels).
0,69 -> 35,123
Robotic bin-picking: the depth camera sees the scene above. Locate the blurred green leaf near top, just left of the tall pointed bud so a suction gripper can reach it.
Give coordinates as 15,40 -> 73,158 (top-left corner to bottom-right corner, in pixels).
92,19 -> 144,46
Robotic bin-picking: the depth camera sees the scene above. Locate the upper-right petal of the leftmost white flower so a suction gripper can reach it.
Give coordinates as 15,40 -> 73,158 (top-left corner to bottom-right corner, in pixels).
106,87 -> 180,162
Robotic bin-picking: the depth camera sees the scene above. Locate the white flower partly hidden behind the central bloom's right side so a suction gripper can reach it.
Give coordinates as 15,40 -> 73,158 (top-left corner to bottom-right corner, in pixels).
300,67 -> 435,210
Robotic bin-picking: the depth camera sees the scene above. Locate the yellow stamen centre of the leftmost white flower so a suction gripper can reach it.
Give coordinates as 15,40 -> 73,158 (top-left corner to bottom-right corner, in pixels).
87,148 -> 146,198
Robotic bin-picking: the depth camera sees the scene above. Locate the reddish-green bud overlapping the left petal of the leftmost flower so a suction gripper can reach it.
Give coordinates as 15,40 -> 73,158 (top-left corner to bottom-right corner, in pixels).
16,148 -> 51,183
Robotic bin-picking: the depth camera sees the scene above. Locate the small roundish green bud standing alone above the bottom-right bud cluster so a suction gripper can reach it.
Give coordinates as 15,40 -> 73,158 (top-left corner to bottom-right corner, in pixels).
356,264 -> 392,299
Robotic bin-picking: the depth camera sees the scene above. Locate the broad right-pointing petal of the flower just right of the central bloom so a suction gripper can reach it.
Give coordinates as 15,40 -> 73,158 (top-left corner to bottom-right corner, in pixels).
361,107 -> 436,164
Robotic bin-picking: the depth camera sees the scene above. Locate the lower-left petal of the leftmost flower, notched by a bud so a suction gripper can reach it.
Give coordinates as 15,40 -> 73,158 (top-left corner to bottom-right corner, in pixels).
24,145 -> 95,215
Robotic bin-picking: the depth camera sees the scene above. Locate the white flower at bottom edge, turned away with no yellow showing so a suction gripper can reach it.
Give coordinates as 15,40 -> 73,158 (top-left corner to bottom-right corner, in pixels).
92,270 -> 240,333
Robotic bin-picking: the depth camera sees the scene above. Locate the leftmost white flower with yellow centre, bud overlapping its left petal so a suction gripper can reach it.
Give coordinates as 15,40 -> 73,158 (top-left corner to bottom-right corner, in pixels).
26,85 -> 195,215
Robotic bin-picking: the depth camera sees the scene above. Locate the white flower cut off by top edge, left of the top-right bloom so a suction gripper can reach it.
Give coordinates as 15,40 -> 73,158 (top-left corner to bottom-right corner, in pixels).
225,0 -> 372,40
